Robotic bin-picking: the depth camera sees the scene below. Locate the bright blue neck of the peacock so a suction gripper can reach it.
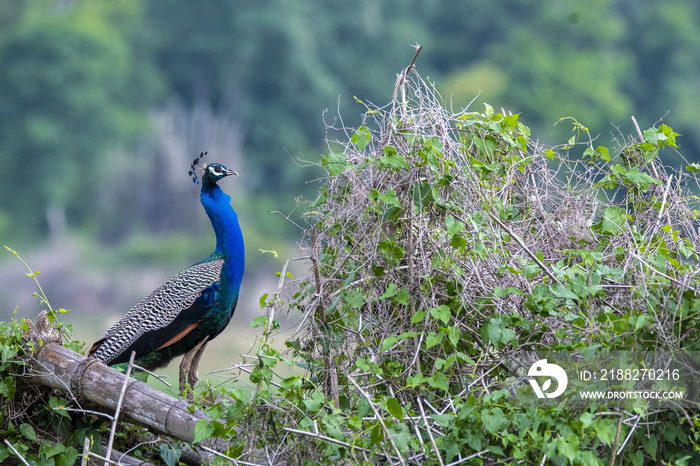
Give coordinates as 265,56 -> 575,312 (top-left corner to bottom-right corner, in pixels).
200,185 -> 245,299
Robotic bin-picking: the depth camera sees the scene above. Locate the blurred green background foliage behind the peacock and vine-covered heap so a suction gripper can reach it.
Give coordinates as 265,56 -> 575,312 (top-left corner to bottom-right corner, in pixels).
0,0 -> 700,354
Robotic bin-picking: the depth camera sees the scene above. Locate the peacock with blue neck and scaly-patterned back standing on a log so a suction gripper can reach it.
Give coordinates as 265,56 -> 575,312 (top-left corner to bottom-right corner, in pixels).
89,152 -> 245,390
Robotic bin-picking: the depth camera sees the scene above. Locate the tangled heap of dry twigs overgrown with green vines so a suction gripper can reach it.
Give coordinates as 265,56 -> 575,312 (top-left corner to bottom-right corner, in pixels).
286,63 -> 700,460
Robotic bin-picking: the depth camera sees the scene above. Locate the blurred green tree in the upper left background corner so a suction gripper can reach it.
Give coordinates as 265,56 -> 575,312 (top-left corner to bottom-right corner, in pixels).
0,2 -> 158,244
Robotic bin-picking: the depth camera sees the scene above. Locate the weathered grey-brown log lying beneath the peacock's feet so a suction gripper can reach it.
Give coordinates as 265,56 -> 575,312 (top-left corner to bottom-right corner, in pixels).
30,343 -> 226,451
